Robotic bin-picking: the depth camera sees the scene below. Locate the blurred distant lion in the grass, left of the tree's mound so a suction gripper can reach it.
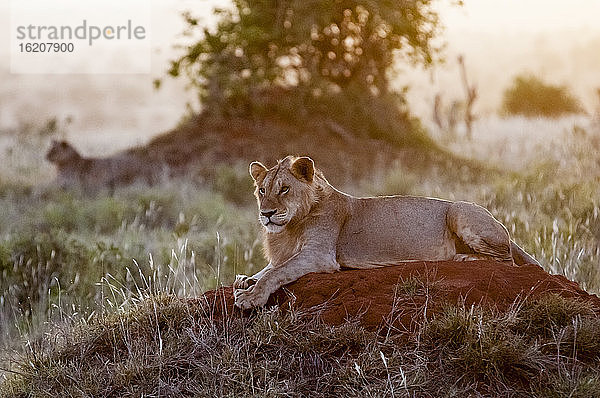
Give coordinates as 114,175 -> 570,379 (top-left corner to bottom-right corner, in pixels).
46,140 -> 157,191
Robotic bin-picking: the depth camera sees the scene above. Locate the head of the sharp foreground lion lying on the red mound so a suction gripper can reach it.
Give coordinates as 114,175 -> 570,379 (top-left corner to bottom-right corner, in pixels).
250,156 -> 324,233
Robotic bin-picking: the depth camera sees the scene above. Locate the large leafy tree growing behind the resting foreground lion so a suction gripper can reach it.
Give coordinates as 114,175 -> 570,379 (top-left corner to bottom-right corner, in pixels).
170,0 -> 438,145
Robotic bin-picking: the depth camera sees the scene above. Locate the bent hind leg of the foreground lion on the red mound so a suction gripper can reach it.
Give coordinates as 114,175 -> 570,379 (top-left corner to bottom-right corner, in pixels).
446,202 -> 514,264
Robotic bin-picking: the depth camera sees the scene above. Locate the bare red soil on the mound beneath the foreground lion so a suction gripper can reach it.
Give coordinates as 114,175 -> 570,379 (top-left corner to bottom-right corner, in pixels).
203,261 -> 600,332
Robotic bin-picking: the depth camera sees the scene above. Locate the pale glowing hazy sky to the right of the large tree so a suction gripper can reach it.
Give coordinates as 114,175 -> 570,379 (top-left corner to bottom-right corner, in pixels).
420,0 -> 600,114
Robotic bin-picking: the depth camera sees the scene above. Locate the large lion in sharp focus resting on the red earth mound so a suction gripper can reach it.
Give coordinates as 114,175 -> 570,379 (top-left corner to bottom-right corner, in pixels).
233,156 -> 539,309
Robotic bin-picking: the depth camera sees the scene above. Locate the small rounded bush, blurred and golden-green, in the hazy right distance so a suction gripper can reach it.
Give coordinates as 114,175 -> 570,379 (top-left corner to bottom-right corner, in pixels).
502,75 -> 583,117
